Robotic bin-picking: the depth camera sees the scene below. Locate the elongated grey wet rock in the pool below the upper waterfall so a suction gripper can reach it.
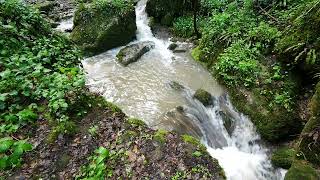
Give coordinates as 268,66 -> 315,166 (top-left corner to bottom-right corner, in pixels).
117,41 -> 155,66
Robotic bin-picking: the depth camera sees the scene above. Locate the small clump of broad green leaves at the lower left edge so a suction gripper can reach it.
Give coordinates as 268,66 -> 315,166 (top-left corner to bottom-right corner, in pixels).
0,137 -> 32,170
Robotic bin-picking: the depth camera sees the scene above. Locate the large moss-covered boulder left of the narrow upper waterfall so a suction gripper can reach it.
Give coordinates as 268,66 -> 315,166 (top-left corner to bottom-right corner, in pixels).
70,0 -> 137,54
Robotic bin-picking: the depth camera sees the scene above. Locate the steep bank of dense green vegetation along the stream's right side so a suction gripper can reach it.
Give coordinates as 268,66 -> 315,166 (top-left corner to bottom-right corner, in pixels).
148,0 -> 320,179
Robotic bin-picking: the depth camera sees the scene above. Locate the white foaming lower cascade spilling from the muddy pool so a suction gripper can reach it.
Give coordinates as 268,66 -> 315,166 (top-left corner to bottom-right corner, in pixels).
175,86 -> 283,180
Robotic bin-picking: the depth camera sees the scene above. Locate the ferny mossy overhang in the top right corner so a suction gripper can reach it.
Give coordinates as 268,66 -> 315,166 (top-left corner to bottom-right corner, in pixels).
277,0 -> 320,71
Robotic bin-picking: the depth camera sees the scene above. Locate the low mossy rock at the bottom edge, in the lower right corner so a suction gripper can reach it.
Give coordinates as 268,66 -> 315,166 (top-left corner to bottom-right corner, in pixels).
284,160 -> 320,180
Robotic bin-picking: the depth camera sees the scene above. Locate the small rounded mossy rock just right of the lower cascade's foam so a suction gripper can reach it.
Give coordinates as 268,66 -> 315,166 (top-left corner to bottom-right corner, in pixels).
271,147 -> 296,169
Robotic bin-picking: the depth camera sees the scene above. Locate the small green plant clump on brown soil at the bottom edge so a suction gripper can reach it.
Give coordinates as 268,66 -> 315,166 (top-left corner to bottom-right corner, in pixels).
76,147 -> 112,180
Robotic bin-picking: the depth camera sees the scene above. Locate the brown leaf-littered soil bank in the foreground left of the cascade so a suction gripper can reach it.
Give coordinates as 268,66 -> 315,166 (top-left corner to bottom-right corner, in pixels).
0,103 -> 224,179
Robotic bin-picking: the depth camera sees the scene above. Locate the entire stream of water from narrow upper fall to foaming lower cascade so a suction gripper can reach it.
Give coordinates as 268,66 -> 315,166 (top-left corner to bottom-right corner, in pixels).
83,0 -> 284,180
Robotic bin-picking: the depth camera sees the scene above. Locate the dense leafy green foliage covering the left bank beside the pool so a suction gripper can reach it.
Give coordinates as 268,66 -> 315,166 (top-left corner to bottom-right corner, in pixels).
0,0 -> 84,143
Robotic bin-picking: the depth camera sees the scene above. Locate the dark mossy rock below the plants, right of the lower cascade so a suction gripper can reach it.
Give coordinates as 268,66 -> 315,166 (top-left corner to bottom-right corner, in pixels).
228,87 -> 302,142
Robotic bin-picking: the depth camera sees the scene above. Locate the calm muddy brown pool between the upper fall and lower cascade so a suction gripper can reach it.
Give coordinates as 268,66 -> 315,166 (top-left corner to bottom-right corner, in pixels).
83,47 -> 223,125
